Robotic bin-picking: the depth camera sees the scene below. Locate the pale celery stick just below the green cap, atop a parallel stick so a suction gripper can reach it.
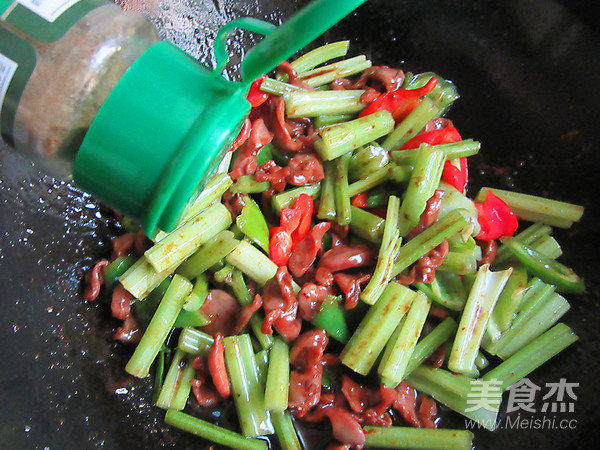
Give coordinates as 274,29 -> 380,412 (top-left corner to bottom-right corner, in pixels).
144,203 -> 231,272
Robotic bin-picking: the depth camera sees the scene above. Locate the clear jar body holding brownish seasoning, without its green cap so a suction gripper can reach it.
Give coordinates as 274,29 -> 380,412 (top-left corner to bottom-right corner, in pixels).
0,0 -> 158,177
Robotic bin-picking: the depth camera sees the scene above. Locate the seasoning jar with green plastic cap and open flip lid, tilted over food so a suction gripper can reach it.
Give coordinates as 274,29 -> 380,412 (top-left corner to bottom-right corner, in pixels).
0,0 -> 365,236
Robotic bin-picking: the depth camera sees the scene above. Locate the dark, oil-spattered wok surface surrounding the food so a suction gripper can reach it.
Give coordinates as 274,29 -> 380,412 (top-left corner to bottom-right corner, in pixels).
0,0 -> 600,449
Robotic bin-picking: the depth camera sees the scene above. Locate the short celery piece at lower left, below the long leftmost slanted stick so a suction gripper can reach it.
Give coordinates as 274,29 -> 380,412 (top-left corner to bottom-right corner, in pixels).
156,350 -> 196,411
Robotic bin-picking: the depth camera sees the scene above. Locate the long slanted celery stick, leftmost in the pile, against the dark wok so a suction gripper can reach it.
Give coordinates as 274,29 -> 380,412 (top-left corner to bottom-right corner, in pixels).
125,275 -> 192,378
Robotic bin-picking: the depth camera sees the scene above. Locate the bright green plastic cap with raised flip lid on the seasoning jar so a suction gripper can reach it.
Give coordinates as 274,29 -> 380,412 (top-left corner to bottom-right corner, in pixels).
73,0 -> 366,236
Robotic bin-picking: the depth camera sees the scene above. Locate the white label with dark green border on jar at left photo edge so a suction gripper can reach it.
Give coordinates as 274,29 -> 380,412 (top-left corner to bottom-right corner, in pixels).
0,26 -> 37,145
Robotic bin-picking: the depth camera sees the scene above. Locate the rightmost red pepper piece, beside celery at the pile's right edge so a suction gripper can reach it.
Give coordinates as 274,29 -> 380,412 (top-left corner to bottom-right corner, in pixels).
475,191 -> 519,241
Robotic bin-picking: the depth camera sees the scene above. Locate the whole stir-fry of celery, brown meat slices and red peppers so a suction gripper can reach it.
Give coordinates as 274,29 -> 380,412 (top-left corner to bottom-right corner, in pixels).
85,41 -> 585,449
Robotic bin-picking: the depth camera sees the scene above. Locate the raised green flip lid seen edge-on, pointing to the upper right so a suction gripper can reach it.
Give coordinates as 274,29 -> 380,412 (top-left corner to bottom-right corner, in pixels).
242,0 -> 366,84
